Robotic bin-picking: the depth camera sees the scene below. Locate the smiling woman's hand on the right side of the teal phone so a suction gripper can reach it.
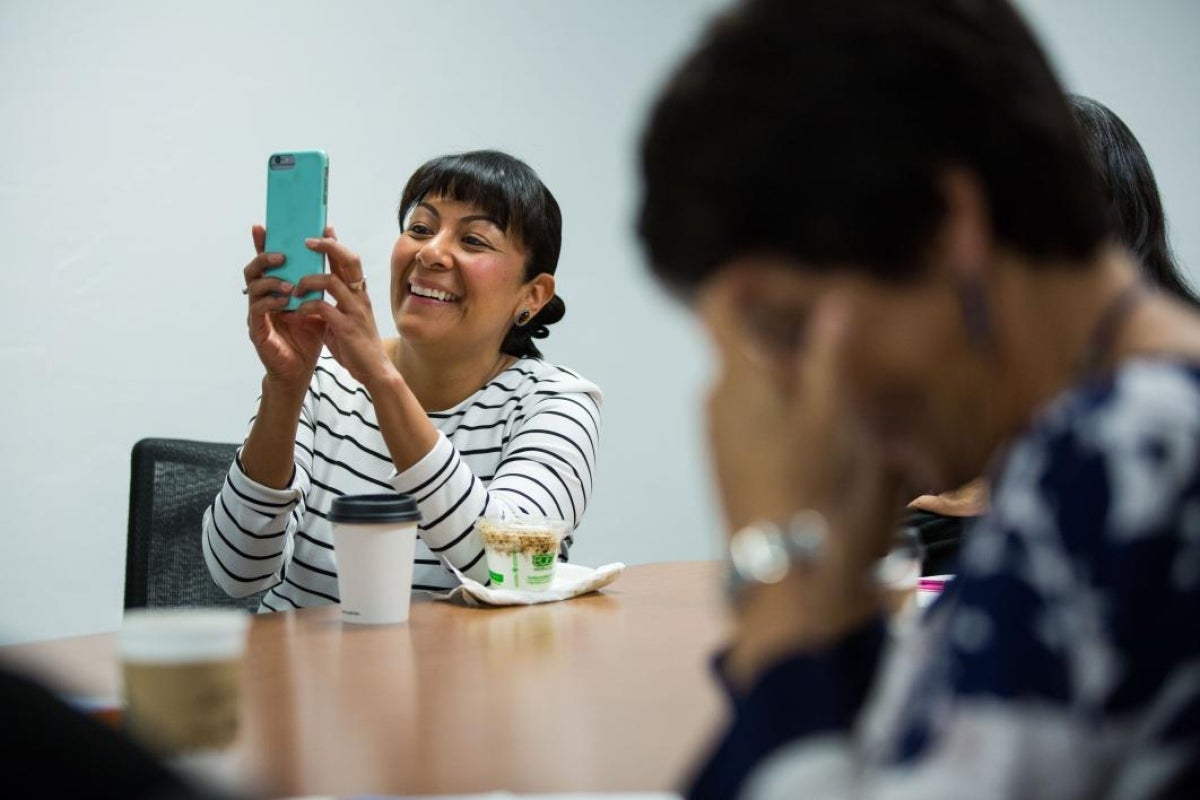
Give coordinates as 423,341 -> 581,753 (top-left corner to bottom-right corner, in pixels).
296,228 -> 395,391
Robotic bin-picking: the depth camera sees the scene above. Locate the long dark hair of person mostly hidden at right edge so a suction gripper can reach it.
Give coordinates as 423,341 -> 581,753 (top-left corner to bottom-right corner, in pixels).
1070,95 -> 1200,306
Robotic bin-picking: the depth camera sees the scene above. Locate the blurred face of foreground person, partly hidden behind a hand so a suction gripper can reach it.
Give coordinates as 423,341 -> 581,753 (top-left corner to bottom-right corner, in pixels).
705,260 -> 996,494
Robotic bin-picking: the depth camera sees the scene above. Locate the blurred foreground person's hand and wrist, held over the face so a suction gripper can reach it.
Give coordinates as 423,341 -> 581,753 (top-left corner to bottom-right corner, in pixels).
697,270 -> 904,682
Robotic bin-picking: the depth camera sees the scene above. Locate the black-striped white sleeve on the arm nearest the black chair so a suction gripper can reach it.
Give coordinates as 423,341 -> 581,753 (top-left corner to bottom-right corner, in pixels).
202,389 -> 316,597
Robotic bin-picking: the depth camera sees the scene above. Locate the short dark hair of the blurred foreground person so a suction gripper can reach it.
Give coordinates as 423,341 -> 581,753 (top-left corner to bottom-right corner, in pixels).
638,0 -> 1105,296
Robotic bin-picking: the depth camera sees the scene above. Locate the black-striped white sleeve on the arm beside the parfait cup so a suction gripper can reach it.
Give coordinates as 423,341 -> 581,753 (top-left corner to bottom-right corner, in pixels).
391,390 -> 600,583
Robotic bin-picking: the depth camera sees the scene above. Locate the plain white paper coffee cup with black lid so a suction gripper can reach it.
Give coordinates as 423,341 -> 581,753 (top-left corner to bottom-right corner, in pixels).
329,494 -> 421,625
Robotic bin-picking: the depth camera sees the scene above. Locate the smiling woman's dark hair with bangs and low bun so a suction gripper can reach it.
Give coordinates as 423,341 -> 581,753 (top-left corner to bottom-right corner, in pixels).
398,150 -> 566,359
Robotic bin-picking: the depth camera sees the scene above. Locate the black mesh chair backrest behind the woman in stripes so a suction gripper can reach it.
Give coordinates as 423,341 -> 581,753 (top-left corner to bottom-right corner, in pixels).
125,438 -> 262,612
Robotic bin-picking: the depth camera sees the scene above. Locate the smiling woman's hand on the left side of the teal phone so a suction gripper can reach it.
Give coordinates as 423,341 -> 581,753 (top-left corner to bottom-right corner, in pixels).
242,225 -> 330,387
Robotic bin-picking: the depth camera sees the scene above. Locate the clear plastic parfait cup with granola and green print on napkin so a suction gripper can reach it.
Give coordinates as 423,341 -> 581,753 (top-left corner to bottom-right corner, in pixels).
475,516 -> 570,591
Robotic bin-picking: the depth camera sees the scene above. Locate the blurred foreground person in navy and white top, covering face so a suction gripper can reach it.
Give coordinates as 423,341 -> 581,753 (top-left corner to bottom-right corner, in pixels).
638,0 -> 1200,800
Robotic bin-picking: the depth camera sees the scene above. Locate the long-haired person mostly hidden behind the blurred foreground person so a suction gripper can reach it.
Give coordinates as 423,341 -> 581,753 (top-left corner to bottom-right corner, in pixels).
904,95 -> 1200,575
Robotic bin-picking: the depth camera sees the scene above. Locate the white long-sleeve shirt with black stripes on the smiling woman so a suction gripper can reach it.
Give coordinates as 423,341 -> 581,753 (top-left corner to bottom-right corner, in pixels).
203,354 -> 601,610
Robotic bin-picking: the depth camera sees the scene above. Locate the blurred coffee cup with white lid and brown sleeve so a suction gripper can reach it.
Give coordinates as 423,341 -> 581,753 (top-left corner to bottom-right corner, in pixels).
118,608 -> 250,756
